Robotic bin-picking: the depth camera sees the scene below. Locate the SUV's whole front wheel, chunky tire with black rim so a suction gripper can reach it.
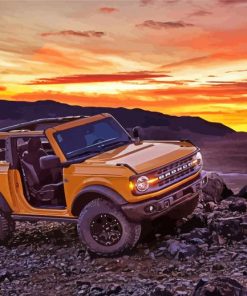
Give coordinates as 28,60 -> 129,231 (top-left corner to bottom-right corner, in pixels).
77,198 -> 141,256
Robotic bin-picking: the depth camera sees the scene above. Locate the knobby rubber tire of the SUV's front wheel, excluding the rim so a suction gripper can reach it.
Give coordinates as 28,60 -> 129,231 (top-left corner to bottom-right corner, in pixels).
77,198 -> 141,257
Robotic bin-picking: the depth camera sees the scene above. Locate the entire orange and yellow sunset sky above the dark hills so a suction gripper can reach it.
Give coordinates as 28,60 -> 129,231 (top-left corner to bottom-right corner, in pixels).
0,0 -> 247,131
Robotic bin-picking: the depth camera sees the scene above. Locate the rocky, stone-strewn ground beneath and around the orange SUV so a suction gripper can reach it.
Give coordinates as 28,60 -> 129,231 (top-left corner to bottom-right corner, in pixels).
0,177 -> 247,296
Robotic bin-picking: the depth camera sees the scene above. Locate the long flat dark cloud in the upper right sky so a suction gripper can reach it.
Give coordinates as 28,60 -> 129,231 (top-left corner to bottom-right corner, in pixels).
136,20 -> 194,30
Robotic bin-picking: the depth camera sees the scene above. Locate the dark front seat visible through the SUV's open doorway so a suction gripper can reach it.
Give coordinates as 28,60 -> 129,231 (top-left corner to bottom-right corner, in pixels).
21,138 -> 63,202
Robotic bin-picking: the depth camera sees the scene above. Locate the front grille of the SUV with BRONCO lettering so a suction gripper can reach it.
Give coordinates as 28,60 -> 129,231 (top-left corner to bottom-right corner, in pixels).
155,155 -> 200,189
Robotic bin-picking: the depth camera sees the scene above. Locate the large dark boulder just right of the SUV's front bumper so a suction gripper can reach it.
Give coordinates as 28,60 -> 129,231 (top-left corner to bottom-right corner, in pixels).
203,173 -> 233,202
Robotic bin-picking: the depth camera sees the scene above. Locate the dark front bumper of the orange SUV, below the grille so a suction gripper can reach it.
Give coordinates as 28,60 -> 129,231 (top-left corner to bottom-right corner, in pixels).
122,172 -> 207,222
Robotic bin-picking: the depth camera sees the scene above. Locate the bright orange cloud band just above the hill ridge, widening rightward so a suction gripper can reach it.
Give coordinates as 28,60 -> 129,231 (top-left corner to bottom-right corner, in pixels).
12,82 -> 247,108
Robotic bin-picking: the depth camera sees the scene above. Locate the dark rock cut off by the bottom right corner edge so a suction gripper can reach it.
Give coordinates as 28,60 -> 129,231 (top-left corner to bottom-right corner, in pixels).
193,277 -> 247,296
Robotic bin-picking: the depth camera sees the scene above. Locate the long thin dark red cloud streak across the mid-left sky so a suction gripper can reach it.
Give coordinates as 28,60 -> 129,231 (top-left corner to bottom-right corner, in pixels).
27,71 -> 170,85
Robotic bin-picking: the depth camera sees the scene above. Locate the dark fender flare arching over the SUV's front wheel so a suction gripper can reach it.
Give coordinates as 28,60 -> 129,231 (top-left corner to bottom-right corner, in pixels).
71,185 -> 127,216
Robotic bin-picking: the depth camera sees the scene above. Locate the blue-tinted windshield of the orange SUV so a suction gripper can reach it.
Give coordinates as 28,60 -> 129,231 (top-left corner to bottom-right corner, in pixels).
54,117 -> 131,159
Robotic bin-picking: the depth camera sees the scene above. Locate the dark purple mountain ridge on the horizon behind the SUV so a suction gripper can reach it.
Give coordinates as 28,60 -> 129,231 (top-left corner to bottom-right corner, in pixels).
0,100 -> 233,139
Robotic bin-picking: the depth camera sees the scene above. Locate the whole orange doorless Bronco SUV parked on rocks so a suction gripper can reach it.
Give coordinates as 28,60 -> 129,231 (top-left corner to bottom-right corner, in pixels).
0,114 -> 206,255
